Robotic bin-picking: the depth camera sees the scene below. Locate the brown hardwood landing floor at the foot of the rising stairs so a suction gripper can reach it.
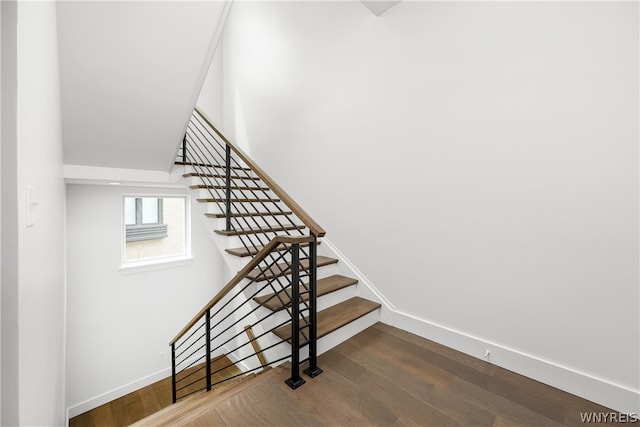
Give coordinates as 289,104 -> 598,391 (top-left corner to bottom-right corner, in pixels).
71,323 -> 612,427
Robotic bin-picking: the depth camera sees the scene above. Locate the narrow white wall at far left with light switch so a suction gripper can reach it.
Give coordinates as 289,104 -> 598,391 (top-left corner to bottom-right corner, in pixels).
2,2 -> 65,426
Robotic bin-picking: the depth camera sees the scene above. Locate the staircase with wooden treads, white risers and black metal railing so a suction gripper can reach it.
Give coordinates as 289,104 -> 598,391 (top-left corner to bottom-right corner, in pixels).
170,108 -> 380,403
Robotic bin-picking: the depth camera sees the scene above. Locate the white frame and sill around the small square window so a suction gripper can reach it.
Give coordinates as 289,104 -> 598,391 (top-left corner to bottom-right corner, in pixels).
120,192 -> 193,273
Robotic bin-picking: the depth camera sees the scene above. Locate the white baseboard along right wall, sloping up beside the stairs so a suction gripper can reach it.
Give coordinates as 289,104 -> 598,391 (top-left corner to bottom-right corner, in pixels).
322,237 -> 640,415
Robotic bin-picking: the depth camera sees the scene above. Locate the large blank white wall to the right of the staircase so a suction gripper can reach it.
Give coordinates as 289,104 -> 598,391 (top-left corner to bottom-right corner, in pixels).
223,1 -> 640,412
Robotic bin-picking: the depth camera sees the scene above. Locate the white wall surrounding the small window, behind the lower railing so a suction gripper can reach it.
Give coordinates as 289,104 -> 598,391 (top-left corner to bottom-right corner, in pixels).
67,185 -> 227,417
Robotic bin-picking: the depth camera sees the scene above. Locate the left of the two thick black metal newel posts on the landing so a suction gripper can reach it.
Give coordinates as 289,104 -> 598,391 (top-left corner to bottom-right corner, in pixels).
284,243 -> 305,390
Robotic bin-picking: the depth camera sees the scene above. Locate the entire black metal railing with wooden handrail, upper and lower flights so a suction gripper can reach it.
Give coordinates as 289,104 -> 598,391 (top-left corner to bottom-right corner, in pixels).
170,109 -> 324,402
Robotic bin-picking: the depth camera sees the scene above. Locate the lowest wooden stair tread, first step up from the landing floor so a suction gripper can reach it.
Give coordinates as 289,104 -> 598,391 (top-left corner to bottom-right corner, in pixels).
273,297 -> 380,346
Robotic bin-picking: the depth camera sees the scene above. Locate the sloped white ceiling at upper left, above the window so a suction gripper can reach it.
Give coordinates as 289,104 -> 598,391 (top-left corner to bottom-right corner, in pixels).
58,1 -> 225,171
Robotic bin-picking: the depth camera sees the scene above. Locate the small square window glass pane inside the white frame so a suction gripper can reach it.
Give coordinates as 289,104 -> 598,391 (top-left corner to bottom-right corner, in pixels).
122,195 -> 189,264
